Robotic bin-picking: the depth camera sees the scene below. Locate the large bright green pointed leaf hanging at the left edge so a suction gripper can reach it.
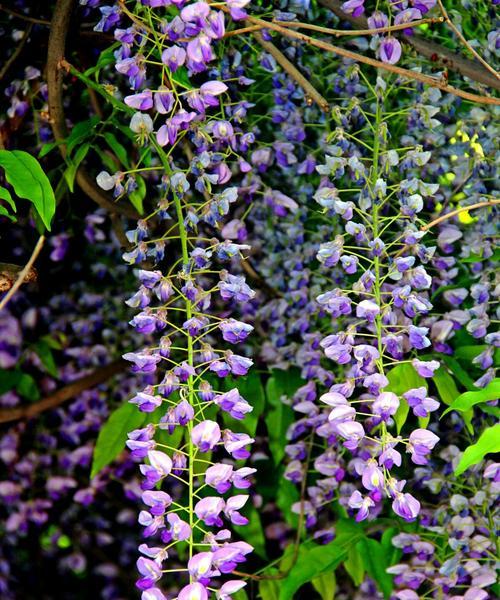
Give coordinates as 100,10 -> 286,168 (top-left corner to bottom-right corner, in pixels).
0,150 -> 56,231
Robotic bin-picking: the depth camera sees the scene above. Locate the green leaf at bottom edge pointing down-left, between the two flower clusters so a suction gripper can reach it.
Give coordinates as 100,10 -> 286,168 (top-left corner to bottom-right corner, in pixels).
279,521 -> 363,600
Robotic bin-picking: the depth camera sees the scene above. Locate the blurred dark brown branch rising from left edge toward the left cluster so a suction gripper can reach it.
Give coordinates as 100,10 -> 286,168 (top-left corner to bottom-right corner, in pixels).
0,358 -> 128,423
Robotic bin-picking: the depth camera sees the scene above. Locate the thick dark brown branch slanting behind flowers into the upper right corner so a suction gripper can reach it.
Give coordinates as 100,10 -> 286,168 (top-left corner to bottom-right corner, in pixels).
319,0 -> 500,90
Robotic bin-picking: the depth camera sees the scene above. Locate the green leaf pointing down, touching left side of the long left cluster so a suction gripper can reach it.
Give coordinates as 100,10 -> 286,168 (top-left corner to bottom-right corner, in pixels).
90,402 -> 146,478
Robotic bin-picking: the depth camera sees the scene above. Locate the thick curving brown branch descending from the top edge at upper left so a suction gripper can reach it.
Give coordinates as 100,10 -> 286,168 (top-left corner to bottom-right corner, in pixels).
47,0 -> 139,219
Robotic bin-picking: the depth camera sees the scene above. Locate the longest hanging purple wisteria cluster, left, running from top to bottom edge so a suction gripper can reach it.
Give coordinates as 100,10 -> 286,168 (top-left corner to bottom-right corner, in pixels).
88,2 -> 255,600
